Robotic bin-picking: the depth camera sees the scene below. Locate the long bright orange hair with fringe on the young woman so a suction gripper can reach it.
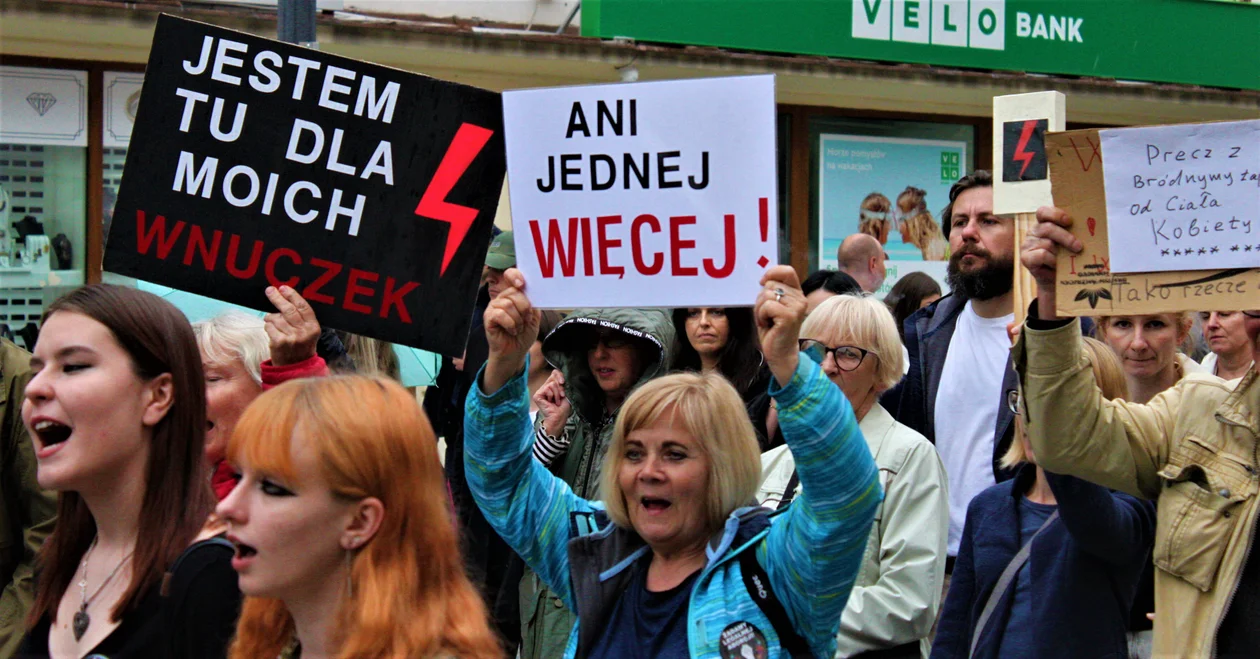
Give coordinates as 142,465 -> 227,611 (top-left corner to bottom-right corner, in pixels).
227,375 -> 503,659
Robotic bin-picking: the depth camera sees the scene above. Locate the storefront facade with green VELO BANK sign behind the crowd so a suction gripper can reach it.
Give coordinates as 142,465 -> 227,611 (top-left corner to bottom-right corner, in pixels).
0,0 -> 1260,320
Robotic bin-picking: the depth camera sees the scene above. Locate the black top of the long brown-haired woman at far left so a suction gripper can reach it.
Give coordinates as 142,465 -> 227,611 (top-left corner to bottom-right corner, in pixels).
15,541 -> 241,659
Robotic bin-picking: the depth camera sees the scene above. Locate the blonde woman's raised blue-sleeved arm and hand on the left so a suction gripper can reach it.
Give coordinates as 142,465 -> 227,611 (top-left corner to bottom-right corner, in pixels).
464,268 -> 595,610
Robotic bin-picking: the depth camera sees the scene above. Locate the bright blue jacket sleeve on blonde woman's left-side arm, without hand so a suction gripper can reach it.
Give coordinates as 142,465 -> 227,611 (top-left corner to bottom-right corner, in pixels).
464,367 -> 596,610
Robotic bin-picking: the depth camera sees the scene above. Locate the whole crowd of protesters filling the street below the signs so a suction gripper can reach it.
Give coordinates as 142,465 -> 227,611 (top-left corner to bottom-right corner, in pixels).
0,166 -> 1260,659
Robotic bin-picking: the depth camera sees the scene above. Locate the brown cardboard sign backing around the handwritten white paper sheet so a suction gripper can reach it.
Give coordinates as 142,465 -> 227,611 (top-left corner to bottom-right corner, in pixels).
1046,129 -> 1260,316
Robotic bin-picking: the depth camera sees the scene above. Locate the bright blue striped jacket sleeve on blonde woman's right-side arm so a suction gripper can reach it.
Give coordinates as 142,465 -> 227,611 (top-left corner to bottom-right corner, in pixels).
757,358 -> 883,651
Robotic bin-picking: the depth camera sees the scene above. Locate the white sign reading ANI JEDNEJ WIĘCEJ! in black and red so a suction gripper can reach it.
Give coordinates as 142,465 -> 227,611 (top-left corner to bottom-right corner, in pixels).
503,76 -> 779,309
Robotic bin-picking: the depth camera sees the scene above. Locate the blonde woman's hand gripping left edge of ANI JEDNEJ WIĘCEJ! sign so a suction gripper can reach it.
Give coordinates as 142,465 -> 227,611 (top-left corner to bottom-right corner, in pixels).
481,268 -> 542,393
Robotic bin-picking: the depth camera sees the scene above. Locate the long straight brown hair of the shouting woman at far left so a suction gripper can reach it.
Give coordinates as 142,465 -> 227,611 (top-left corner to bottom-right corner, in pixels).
26,284 -> 214,627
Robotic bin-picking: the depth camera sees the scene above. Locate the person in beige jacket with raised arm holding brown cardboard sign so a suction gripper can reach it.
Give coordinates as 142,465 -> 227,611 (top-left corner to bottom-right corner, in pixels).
1014,208 -> 1260,658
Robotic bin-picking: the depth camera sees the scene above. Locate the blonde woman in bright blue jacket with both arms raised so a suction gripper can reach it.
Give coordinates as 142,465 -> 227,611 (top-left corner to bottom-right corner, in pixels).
465,267 -> 881,659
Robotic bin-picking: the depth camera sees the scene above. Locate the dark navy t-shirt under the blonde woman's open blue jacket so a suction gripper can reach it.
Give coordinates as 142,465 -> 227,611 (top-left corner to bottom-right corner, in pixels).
588,552 -> 701,659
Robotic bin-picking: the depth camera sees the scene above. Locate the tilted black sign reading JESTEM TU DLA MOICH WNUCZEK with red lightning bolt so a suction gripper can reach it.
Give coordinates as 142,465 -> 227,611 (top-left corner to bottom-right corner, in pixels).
105,15 -> 505,355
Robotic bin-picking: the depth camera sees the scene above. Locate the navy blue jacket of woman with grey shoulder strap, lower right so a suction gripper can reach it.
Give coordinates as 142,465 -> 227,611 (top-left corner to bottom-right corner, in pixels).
932,465 -> 1155,659
